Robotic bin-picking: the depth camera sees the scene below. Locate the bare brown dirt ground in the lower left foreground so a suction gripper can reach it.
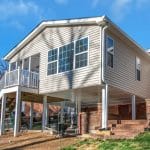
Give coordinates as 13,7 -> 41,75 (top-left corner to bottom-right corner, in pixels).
0,132 -> 78,150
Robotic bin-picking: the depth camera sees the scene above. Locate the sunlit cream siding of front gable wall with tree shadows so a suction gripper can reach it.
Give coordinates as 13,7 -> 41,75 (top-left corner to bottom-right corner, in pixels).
10,25 -> 101,93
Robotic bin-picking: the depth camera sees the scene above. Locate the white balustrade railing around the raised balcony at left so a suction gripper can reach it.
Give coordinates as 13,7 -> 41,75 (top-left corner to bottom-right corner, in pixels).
0,69 -> 39,90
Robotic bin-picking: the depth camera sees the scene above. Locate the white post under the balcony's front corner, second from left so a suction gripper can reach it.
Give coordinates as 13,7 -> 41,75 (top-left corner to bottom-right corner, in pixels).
14,86 -> 21,137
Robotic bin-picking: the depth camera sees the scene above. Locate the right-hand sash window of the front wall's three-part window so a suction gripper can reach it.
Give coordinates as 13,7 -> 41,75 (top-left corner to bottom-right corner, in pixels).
75,38 -> 88,68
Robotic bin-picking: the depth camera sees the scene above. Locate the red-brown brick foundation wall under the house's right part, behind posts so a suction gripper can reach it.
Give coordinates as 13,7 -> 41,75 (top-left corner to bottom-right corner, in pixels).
79,101 -> 146,134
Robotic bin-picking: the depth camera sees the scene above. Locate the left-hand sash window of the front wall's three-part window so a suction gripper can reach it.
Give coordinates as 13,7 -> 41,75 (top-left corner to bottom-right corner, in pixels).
47,48 -> 58,75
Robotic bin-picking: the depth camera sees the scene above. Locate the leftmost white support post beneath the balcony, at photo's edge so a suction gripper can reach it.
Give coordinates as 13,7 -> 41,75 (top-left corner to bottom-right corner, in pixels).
0,94 -> 6,135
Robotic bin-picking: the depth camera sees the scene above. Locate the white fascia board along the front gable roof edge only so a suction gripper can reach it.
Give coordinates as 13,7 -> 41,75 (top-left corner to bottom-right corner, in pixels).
4,16 -> 105,60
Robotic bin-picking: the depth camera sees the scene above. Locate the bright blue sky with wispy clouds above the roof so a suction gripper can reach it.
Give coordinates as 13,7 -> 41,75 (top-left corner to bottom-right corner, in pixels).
0,0 -> 150,57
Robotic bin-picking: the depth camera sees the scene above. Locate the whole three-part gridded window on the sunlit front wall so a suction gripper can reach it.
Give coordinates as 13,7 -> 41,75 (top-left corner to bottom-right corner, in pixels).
47,38 -> 88,75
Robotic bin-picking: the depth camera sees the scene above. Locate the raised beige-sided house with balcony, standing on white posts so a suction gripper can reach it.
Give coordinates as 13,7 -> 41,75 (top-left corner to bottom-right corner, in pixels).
0,16 -> 150,136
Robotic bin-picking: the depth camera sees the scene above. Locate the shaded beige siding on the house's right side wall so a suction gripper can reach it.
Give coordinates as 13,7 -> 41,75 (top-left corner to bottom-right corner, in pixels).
105,30 -> 150,98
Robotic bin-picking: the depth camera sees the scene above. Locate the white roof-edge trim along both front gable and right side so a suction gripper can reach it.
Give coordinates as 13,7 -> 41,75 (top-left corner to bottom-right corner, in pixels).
4,16 -> 150,60
